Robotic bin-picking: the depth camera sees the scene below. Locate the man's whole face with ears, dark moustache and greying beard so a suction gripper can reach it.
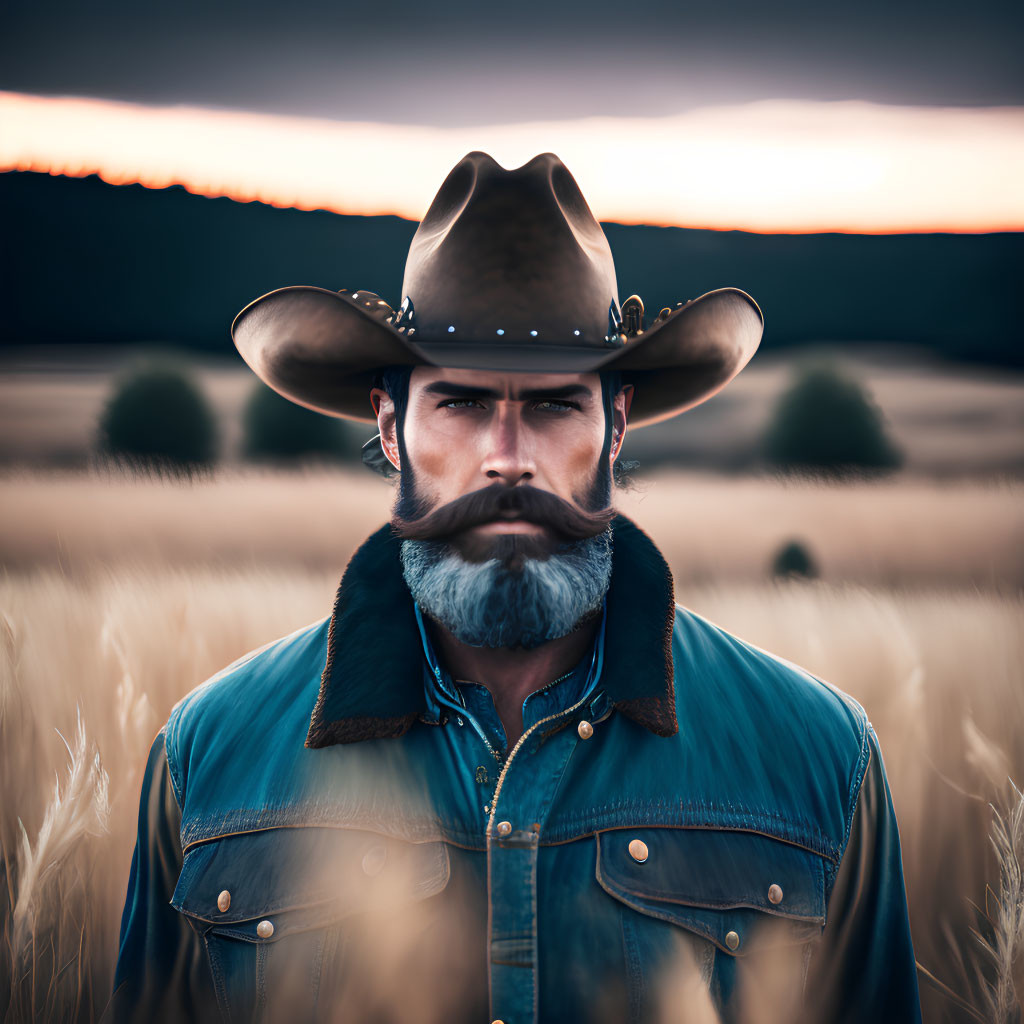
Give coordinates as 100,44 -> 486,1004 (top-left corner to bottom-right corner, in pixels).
372,367 -> 632,648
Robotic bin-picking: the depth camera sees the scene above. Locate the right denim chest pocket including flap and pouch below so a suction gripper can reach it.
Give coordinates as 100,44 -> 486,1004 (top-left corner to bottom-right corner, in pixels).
596,827 -> 825,1019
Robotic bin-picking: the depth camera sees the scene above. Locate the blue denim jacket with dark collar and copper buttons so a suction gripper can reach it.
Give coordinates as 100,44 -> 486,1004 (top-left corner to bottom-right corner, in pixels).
108,516 -> 921,1024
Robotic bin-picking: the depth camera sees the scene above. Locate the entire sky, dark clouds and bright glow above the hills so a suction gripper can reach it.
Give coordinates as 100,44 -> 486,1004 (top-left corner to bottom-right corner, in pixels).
0,0 -> 1024,230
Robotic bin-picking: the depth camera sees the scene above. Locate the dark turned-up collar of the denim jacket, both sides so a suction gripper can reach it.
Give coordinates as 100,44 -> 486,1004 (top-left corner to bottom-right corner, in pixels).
306,514 -> 679,748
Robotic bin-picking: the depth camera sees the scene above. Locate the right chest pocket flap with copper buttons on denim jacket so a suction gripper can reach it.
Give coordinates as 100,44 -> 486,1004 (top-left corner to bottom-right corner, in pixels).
597,828 -> 825,955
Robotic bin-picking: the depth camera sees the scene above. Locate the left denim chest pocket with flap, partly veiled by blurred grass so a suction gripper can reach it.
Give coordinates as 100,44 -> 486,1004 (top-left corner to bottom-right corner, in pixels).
171,827 -> 450,1024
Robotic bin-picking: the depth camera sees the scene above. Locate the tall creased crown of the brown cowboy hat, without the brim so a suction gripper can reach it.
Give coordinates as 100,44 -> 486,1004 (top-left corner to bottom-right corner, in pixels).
402,152 -> 616,351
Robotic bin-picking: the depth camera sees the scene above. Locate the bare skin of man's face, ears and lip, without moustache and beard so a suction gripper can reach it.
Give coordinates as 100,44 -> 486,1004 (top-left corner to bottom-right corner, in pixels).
371,367 -> 632,535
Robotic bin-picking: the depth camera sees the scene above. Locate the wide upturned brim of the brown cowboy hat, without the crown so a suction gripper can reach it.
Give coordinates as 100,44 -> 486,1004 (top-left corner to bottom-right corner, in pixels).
231,286 -> 764,427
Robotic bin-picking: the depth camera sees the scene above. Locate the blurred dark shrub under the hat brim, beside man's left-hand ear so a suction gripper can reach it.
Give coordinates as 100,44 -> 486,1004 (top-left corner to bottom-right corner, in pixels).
242,381 -> 360,462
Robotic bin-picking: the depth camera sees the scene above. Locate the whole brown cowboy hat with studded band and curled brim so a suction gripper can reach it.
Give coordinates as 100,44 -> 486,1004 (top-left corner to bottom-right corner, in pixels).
231,153 -> 764,426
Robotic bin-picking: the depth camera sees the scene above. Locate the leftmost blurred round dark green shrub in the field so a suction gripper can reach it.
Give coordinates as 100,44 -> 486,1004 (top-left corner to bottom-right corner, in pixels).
98,362 -> 218,470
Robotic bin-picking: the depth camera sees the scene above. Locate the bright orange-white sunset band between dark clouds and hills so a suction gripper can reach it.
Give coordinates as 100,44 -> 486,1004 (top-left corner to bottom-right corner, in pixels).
0,92 -> 1024,233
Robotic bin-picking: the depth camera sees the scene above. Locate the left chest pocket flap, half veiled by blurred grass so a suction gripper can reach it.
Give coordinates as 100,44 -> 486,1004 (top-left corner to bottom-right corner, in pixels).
171,827 -> 450,942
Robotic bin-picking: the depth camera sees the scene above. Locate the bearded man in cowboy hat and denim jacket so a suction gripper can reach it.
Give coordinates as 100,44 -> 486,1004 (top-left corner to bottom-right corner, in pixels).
111,153 -> 920,1024
